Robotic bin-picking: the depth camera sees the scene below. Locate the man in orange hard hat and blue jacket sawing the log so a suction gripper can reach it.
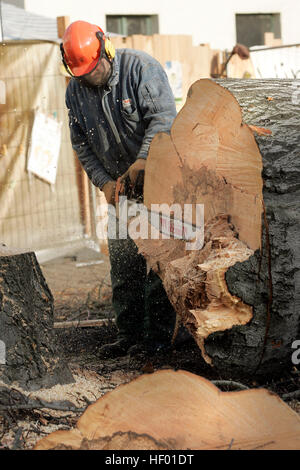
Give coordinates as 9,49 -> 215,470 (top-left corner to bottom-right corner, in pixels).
61,21 -> 176,357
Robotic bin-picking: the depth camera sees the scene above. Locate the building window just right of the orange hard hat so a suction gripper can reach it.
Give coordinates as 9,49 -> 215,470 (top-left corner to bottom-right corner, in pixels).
106,15 -> 158,36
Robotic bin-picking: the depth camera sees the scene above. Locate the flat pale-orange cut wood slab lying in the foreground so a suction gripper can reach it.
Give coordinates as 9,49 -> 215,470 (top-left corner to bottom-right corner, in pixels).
35,370 -> 300,450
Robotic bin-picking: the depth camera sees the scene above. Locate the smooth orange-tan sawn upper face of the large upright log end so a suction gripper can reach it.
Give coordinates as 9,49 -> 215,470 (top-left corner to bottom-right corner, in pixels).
145,79 -> 263,250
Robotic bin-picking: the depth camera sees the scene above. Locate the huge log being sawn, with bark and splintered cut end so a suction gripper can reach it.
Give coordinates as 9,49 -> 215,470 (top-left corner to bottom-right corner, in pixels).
135,79 -> 300,378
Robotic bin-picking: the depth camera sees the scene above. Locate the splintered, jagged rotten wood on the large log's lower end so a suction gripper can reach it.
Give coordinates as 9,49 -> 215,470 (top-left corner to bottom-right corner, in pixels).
165,216 -> 253,364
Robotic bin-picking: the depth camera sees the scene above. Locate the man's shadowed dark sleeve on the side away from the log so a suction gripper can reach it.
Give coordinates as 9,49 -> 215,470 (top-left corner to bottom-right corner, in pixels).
66,95 -> 113,190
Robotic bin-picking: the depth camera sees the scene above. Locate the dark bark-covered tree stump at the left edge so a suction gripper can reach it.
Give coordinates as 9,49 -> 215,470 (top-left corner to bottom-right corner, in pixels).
0,247 -> 74,391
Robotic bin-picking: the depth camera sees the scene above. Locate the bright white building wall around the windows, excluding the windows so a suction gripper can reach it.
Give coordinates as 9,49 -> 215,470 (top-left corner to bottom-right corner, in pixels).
25,0 -> 300,49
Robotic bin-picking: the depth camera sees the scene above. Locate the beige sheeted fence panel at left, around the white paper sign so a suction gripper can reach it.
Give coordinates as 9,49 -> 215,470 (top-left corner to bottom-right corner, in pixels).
0,41 -> 84,250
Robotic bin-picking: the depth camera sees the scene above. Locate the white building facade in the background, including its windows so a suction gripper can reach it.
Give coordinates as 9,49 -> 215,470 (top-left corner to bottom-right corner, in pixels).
2,0 -> 300,50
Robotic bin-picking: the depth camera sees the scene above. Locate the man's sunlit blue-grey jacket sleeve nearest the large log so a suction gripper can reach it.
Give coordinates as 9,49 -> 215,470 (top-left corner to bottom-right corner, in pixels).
137,62 -> 177,159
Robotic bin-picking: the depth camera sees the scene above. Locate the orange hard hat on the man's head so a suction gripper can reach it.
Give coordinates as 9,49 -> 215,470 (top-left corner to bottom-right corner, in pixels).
62,21 -> 105,77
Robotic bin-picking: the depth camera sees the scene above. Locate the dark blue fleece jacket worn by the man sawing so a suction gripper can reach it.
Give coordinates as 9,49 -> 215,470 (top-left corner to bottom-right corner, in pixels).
66,49 -> 176,189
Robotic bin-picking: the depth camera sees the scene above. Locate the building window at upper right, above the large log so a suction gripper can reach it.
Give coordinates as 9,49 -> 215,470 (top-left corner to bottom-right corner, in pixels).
235,13 -> 281,47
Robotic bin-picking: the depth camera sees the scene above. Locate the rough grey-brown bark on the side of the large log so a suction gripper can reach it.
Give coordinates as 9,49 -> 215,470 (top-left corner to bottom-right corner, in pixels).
206,80 -> 300,374
